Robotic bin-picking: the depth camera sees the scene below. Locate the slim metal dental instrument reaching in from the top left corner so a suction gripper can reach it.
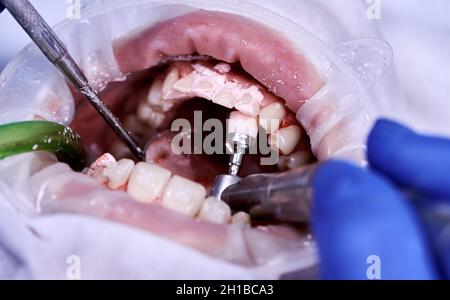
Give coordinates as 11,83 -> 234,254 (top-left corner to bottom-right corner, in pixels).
0,0 -> 144,160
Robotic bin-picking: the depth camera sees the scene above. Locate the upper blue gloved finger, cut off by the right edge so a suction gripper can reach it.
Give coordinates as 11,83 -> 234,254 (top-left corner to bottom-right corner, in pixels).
368,120 -> 450,197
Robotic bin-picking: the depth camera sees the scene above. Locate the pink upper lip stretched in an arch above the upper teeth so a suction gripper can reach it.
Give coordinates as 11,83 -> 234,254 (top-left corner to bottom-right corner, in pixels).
115,10 -> 324,112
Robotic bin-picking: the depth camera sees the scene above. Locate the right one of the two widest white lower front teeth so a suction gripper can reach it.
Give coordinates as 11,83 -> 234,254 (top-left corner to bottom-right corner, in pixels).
162,176 -> 206,217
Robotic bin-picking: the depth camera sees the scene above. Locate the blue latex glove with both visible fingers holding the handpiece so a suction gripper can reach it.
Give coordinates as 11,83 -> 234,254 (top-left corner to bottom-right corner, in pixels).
312,120 -> 450,279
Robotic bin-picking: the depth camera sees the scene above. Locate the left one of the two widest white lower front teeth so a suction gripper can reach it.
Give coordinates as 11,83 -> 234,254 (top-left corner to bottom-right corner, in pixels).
128,162 -> 171,203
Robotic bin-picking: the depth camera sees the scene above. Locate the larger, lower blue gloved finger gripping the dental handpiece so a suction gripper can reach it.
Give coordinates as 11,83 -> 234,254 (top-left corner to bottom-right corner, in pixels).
312,162 -> 438,279
